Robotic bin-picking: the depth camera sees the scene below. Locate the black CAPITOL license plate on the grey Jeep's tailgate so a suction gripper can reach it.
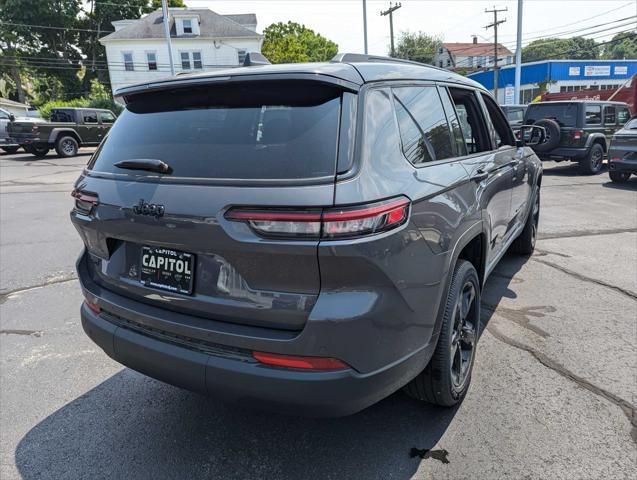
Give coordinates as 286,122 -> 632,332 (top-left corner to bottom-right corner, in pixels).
139,245 -> 195,295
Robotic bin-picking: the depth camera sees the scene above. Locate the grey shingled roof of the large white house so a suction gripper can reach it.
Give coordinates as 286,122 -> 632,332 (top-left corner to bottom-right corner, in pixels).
100,8 -> 261,42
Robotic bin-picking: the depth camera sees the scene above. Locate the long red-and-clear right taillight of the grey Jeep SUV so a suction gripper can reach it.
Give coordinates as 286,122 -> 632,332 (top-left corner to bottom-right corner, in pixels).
225,197 -> 410,239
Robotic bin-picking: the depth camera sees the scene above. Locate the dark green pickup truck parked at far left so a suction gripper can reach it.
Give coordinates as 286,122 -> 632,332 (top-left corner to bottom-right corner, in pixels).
8,107 -> 116,157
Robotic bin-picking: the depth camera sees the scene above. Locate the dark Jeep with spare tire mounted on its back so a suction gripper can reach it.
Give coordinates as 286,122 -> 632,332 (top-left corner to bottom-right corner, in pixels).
524,100 -> 630,175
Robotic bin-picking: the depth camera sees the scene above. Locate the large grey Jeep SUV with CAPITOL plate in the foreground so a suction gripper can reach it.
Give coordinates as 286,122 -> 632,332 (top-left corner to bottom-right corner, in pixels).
71,54 -> 543,416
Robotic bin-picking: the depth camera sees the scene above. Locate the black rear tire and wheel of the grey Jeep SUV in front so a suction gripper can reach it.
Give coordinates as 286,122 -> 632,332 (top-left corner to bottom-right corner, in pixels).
404,260 -> 480,407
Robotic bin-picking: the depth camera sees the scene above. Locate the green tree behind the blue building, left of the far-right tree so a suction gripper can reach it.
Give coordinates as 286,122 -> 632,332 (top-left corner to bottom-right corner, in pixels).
522,37 -> 600,63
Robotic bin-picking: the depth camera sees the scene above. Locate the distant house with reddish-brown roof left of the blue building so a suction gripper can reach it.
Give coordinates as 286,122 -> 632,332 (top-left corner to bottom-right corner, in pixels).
433,37 -> 513,70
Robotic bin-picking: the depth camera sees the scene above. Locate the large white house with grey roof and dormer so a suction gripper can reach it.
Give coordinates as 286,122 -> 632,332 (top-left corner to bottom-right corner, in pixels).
100,8 -> 263,92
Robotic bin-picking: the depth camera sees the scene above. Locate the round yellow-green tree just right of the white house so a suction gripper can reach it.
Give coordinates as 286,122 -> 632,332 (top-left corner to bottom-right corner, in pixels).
261,22 -> 338,63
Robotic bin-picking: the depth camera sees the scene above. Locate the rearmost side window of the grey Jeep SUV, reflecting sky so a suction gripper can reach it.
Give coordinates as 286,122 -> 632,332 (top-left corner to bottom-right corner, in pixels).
392,87 -> 454,165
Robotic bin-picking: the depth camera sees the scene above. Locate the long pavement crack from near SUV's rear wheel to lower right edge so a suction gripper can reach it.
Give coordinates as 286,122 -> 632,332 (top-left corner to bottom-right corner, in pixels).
487,323 -> 637,444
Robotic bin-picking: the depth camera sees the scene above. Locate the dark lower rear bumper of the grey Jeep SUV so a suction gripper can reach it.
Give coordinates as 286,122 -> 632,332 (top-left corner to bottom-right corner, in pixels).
81,304 -> 435,417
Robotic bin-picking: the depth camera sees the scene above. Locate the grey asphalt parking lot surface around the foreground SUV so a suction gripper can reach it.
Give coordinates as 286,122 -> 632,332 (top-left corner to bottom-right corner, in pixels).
0,150 -> 637,480
